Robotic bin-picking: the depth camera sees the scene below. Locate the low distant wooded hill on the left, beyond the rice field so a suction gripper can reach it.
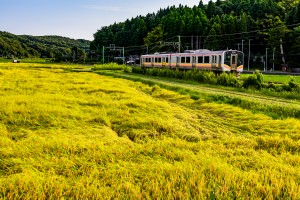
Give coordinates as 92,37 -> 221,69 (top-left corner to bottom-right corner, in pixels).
0,31 -> 90,62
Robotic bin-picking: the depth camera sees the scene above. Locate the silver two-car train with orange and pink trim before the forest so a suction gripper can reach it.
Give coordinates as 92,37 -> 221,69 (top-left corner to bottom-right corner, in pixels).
140,49 -> 244,72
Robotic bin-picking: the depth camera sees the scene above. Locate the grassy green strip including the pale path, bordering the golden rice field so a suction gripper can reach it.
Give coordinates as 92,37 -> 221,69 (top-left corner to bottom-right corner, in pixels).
96,70 -> 300,119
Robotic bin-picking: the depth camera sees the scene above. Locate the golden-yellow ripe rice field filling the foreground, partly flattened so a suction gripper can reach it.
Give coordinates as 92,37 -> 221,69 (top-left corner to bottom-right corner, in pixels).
0,63 -> 300,199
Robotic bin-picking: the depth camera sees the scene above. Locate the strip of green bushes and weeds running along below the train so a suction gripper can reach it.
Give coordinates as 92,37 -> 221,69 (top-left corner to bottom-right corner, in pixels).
132,67 -> 300,94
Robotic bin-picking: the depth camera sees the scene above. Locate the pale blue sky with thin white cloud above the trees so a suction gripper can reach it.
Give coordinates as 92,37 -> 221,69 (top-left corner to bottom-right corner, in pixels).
0,0 -> 208,41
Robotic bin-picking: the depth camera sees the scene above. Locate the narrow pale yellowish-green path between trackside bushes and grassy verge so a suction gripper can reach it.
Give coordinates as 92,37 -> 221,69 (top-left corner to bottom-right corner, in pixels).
104,72 -> 300,110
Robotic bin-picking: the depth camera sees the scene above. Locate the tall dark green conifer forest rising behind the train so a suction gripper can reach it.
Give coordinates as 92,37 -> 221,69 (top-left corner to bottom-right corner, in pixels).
91,0 -> 300,68
